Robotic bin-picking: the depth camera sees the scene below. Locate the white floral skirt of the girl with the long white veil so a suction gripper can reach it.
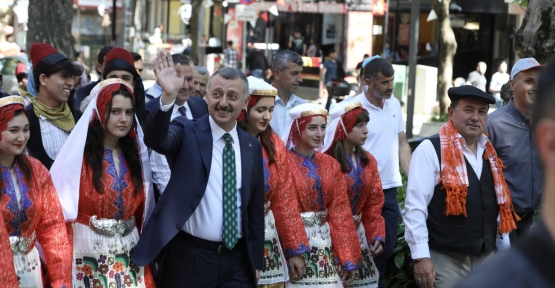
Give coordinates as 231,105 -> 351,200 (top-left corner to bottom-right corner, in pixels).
72,222 -> 146,288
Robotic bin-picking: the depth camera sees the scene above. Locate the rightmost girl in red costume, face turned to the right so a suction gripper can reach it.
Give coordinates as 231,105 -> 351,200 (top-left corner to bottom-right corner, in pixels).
323,102 -> 385,287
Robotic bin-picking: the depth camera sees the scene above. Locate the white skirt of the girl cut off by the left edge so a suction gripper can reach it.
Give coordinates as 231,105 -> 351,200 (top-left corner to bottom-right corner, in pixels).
13,247 -> 42,288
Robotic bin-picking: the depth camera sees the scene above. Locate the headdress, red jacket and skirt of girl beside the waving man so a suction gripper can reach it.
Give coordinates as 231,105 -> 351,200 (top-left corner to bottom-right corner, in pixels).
237,76 -> 310,285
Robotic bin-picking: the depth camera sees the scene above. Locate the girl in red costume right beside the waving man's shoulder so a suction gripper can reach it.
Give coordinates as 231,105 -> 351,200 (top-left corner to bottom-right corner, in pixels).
237,76 -> 310,287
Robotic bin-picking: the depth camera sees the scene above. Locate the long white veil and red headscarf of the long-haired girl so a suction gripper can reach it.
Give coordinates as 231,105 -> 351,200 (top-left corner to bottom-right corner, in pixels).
50,79 -> 154,225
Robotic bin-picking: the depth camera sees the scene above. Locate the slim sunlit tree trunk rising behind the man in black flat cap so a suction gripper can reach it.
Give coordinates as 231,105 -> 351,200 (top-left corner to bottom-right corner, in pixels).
430,0 -> 457,115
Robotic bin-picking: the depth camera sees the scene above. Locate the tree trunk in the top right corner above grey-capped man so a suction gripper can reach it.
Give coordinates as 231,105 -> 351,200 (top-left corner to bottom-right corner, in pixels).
515,0 -> 555,63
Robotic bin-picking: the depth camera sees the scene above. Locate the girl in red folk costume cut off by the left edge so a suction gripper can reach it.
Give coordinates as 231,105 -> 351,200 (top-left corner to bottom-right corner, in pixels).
0,96 -> 72,287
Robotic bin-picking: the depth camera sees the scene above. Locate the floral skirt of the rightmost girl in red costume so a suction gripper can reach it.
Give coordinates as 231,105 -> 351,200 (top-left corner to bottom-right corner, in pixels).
347,223 -> 379,288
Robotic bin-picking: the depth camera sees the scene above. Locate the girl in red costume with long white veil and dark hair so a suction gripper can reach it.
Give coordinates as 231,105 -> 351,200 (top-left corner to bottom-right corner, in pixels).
51,79 -> 155,287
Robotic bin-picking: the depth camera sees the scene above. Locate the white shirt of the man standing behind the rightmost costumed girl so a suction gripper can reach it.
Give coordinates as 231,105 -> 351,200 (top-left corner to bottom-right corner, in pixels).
344,87 -> 404,189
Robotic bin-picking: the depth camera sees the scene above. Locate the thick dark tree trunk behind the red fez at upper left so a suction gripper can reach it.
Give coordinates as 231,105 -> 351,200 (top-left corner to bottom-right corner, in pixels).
27,0 -> 75,59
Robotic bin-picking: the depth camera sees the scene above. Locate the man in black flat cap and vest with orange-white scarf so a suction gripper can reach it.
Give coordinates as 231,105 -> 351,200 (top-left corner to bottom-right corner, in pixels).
403,86 -> 516,288
